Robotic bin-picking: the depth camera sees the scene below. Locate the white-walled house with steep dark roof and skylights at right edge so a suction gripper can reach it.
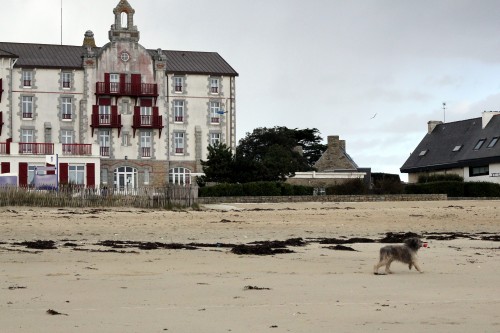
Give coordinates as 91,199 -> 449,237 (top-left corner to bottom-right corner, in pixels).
400,111 -> 500,183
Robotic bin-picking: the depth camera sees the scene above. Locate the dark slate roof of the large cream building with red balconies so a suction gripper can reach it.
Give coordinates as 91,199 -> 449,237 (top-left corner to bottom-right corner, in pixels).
0,42 -> 238,76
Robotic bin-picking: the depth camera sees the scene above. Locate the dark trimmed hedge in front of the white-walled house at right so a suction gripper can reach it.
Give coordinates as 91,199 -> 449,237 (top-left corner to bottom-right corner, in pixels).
405,181 -> 500,198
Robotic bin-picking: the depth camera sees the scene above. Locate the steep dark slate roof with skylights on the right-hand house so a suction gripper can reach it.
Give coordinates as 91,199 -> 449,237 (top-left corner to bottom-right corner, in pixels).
400,115 -> 500,173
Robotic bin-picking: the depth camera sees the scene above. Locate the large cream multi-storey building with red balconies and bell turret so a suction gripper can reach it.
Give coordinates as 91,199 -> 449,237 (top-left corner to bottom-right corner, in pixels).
0,0 -> 238,189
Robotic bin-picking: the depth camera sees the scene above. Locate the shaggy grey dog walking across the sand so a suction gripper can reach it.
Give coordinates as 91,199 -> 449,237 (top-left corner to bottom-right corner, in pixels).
373,237 -> 423,274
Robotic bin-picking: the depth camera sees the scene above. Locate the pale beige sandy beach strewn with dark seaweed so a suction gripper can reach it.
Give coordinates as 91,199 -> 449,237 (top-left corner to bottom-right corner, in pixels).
0,201 -> 500,333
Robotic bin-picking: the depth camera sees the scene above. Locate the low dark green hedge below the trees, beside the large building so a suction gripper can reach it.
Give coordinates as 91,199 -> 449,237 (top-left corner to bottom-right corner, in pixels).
198,182 -> 313,197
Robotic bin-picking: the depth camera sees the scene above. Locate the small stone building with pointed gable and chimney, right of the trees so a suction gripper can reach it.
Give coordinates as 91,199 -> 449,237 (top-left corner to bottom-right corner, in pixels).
287,136 -> 371,188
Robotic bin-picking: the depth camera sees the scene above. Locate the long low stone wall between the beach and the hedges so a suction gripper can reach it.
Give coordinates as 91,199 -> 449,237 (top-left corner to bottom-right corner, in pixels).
197,194 -> 447,204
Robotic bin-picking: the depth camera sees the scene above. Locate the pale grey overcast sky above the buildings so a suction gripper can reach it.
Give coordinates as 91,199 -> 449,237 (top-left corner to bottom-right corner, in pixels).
0,0 -> 500,180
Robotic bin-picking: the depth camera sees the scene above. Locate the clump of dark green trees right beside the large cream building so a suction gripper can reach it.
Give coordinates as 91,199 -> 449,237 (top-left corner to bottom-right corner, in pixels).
201,127 -> 326,183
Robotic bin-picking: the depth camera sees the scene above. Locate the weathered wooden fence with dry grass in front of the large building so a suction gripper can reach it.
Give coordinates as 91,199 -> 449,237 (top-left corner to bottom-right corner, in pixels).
0,185 -> 198,209
